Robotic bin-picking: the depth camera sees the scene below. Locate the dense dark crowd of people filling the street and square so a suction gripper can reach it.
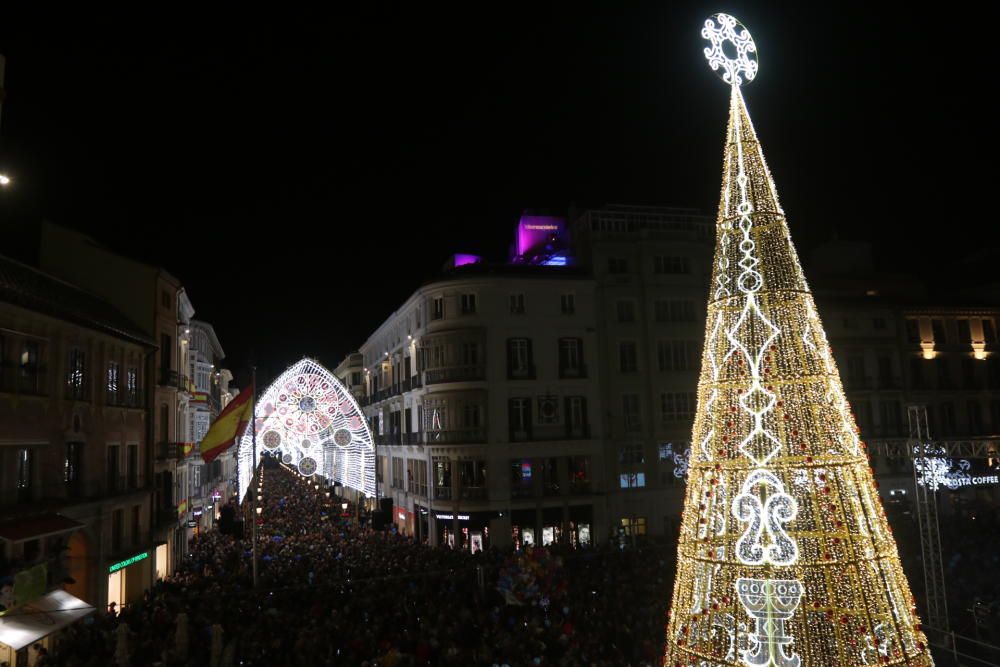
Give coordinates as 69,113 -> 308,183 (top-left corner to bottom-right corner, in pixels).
46,468 -> 675,667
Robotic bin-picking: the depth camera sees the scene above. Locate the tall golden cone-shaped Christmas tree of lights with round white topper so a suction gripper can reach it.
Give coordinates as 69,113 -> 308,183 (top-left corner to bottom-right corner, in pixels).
665,14 -> 933,667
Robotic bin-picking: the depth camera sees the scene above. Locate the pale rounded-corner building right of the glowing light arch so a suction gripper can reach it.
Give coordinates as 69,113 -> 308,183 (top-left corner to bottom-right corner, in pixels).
348,264 -> 607,550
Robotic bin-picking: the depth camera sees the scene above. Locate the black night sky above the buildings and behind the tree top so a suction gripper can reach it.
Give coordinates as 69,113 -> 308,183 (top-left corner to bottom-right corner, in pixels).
0,2 -> 988,380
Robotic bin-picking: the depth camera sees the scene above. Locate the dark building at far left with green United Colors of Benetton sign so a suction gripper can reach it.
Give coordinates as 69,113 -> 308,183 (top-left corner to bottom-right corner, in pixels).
0,253 -> 157,640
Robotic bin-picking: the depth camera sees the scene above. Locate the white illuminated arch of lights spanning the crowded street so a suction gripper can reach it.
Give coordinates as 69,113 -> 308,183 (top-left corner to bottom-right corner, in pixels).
239,359 -> 375,501
